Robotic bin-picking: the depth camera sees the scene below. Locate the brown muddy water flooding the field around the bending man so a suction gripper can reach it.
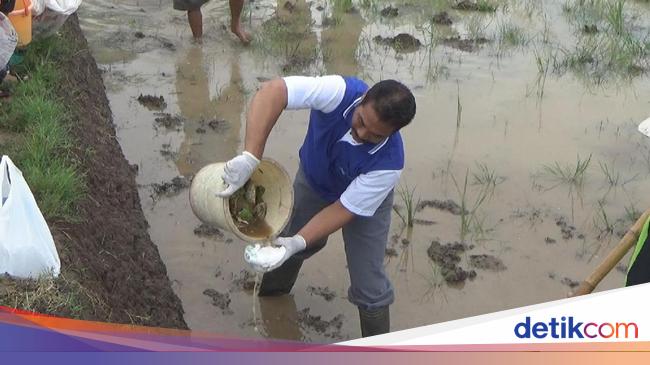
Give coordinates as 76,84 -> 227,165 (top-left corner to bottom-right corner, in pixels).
80,0 -> 650,342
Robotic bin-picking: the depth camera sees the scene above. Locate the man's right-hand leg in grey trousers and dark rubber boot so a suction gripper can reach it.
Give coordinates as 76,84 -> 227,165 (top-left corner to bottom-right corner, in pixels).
343,192 -> 395,337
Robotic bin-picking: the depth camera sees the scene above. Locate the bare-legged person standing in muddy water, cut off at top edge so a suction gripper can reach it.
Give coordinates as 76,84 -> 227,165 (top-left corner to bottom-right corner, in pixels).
173,0 -> 250,44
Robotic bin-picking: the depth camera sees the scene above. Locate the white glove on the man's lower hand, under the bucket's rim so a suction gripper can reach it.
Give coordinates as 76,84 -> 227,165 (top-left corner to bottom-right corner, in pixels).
244,234 -> 307,273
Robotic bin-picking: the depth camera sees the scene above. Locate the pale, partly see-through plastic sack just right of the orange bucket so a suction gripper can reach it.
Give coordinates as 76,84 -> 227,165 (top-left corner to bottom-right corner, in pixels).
32,0 -> 81,39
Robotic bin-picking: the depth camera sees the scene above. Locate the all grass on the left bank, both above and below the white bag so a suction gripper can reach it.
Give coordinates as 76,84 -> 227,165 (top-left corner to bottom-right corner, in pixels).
0,36 -> 97,318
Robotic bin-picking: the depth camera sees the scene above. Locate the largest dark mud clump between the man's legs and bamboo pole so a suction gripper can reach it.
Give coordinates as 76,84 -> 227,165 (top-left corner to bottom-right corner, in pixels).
427,241 -> 476,284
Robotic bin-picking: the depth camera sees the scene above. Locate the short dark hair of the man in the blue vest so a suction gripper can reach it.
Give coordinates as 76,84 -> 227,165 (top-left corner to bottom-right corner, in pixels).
361,80 -> 415,130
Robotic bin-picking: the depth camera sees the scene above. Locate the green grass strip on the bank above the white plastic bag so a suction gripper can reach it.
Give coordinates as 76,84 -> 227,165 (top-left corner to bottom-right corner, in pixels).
0,36 -> 85,221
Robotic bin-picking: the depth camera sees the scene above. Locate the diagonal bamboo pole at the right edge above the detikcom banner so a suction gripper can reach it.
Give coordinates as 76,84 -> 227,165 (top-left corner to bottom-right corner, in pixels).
569,209 -> 650,297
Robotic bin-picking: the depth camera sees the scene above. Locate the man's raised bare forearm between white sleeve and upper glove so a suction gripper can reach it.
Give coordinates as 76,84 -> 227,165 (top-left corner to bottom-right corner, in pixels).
244,78 -> 287,159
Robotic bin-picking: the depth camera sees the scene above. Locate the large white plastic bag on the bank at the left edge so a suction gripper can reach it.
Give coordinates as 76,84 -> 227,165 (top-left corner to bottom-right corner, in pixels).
0,156 -> 61,279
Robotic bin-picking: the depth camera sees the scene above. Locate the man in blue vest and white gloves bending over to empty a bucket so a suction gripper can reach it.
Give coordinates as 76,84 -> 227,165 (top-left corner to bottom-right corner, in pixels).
217,75 -> 416,337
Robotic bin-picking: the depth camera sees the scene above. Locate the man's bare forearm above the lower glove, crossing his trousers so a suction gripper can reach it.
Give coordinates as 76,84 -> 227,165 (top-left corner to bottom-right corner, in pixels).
298,200 -> 354,247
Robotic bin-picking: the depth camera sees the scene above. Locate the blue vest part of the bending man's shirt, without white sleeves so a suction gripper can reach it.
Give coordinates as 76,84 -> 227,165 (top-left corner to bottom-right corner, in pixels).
300,77 -> 404,202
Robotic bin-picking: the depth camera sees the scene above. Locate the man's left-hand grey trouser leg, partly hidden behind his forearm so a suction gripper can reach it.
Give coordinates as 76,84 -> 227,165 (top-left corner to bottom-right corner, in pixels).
259,168 -> 329,297
